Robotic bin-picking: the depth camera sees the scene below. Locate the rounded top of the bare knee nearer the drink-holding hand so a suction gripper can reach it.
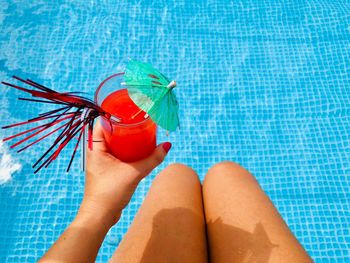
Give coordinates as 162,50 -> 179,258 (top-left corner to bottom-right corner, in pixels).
154,163 -> 200,189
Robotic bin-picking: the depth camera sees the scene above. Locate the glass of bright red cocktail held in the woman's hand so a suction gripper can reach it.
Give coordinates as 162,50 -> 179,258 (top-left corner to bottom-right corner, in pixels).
95,73 -> 157,162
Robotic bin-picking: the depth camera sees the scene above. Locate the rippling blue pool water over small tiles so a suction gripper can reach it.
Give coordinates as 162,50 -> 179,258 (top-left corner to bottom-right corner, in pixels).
0,0 -> 350,262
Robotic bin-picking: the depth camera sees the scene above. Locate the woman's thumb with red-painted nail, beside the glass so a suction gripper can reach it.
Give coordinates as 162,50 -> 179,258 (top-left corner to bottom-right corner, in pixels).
138,142 -> 171,177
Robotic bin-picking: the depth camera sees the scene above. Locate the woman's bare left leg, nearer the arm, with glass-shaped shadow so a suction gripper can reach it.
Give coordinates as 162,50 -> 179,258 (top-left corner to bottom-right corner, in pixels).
111,164 -> 207,263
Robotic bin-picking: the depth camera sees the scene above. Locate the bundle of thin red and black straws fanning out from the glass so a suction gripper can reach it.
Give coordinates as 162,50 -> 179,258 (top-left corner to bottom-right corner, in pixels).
2,76 -> 112,173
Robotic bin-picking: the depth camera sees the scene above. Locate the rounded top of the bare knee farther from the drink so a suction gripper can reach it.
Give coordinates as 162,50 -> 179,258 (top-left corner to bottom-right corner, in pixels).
203,161 -> 256,187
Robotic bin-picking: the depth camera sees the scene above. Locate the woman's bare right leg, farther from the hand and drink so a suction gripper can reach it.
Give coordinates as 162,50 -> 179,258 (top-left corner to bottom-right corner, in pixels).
203,162 -> 312,263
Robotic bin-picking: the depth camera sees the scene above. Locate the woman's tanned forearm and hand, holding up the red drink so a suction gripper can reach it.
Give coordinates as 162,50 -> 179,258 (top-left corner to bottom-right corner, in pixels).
40,124 -> 171,262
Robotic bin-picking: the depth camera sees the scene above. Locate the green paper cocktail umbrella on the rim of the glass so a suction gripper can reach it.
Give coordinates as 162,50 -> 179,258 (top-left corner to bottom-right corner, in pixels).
123,60 -> 179,131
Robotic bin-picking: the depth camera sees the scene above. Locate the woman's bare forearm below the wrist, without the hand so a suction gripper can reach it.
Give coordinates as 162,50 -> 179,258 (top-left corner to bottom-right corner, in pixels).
40,213 -> 110,262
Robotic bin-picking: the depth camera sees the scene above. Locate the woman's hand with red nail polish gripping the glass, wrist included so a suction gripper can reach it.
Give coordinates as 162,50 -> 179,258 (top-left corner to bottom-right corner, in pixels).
78,123 -> 171,227
